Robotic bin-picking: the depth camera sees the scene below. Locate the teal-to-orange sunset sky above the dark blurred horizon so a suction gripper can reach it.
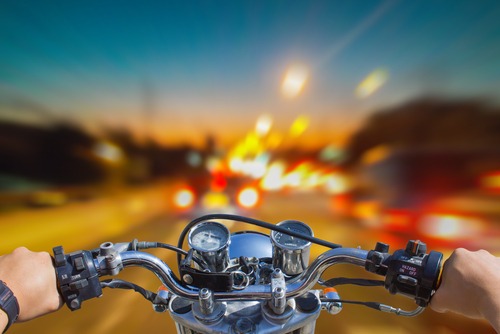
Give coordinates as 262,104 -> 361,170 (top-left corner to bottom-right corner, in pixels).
0,0 -> 500,145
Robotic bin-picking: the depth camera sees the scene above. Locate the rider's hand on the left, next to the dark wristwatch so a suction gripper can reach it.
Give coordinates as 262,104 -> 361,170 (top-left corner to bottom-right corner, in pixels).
0,247 -> 62,321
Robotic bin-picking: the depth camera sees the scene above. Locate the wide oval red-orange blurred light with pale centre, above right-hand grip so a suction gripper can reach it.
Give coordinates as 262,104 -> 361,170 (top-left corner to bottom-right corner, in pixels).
419,214 -> 484,239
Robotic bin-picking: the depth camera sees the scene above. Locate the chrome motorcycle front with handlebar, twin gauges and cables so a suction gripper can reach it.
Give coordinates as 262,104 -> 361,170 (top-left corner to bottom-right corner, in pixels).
54,214 -> 443,334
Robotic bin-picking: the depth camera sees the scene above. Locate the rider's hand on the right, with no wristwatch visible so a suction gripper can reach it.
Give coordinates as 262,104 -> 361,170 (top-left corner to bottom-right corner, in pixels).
430,248 -> 500,332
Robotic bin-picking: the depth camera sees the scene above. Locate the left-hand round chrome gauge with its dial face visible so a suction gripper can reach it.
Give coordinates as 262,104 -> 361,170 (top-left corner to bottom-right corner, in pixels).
188,221 -> 231,272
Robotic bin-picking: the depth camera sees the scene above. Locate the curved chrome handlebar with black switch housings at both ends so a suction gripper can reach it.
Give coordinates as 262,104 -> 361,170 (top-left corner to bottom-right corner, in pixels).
54,243 -> 442,309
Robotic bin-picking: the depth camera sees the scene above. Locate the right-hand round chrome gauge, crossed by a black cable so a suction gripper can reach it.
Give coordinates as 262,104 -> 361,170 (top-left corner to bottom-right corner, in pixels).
271,220 -> 313,276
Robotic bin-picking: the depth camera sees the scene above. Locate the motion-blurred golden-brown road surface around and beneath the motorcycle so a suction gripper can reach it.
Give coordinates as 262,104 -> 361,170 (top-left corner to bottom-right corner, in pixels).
0,183 -> 497,334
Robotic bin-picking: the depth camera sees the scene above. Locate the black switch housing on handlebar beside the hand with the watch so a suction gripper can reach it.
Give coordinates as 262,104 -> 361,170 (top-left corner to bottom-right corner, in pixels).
53,246 -> 102,311
